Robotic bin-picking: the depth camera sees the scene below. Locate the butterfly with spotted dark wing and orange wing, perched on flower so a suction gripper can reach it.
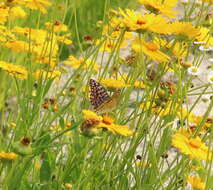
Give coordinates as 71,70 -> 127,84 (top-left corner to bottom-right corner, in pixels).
89,79 -> 121,114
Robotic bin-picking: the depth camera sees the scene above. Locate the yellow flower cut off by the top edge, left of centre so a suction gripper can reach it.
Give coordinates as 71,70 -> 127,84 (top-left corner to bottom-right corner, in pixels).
14,0 -> 52,14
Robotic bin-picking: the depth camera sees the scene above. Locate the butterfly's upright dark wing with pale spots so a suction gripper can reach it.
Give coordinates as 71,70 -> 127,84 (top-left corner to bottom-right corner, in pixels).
89,79 -> 110,109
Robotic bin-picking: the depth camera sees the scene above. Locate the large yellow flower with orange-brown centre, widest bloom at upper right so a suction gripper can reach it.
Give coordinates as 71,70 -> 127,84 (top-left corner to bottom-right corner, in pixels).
120,9 -> 170,34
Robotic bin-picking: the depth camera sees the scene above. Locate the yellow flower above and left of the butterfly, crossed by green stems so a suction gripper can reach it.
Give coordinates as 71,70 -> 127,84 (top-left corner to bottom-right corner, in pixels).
63,56 -> 99,72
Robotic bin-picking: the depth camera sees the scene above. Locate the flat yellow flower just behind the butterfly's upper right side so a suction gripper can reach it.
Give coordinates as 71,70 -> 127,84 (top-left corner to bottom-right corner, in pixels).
100,78 -> 130,88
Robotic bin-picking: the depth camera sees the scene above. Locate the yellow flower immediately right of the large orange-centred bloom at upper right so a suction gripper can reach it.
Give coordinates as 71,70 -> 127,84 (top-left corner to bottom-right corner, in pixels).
169,21 -> 200,39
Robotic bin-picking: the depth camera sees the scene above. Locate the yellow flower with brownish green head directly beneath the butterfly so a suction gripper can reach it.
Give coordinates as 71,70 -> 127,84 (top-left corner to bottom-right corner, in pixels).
80,110 -> 133,136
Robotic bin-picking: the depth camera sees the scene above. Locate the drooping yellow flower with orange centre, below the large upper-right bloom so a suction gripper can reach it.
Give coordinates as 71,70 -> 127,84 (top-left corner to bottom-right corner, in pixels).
132,38 -> 170,62
